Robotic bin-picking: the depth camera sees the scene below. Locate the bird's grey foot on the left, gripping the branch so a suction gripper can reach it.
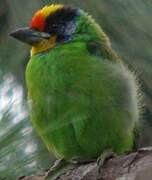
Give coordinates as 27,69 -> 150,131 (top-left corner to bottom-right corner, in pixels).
45,159 -> 73,180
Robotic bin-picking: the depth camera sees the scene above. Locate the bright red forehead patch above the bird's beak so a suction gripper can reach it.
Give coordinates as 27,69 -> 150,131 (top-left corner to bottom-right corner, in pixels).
30,13 -> 45,31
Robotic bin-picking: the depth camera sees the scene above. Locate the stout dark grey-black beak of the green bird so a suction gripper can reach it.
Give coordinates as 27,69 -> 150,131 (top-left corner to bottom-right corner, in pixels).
10,27 -> 51,45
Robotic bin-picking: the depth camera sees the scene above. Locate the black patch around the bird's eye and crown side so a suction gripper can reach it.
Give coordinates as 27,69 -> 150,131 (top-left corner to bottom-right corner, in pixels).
44,6 -> 78,36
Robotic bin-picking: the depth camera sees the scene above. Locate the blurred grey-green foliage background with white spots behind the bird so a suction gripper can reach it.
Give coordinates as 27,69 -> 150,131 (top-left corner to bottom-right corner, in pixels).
0,0 -> 152,180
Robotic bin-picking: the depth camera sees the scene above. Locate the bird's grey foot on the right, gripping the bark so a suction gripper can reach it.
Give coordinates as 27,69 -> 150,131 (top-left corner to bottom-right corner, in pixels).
97,149 -> 116,166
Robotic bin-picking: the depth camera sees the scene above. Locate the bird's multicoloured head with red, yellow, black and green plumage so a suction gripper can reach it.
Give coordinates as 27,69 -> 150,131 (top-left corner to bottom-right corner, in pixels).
10,4 -> 107,56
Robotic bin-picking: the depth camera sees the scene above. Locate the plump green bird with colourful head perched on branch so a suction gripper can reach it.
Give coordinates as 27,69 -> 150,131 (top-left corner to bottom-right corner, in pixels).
11,4 -> 140,165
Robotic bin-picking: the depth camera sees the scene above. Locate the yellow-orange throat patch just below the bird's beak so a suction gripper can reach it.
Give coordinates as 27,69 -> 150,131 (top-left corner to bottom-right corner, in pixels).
31,36 -> 56,56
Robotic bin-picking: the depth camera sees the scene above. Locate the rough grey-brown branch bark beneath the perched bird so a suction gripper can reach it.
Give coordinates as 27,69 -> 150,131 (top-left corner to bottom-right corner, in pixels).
19,147 -> 152,180
